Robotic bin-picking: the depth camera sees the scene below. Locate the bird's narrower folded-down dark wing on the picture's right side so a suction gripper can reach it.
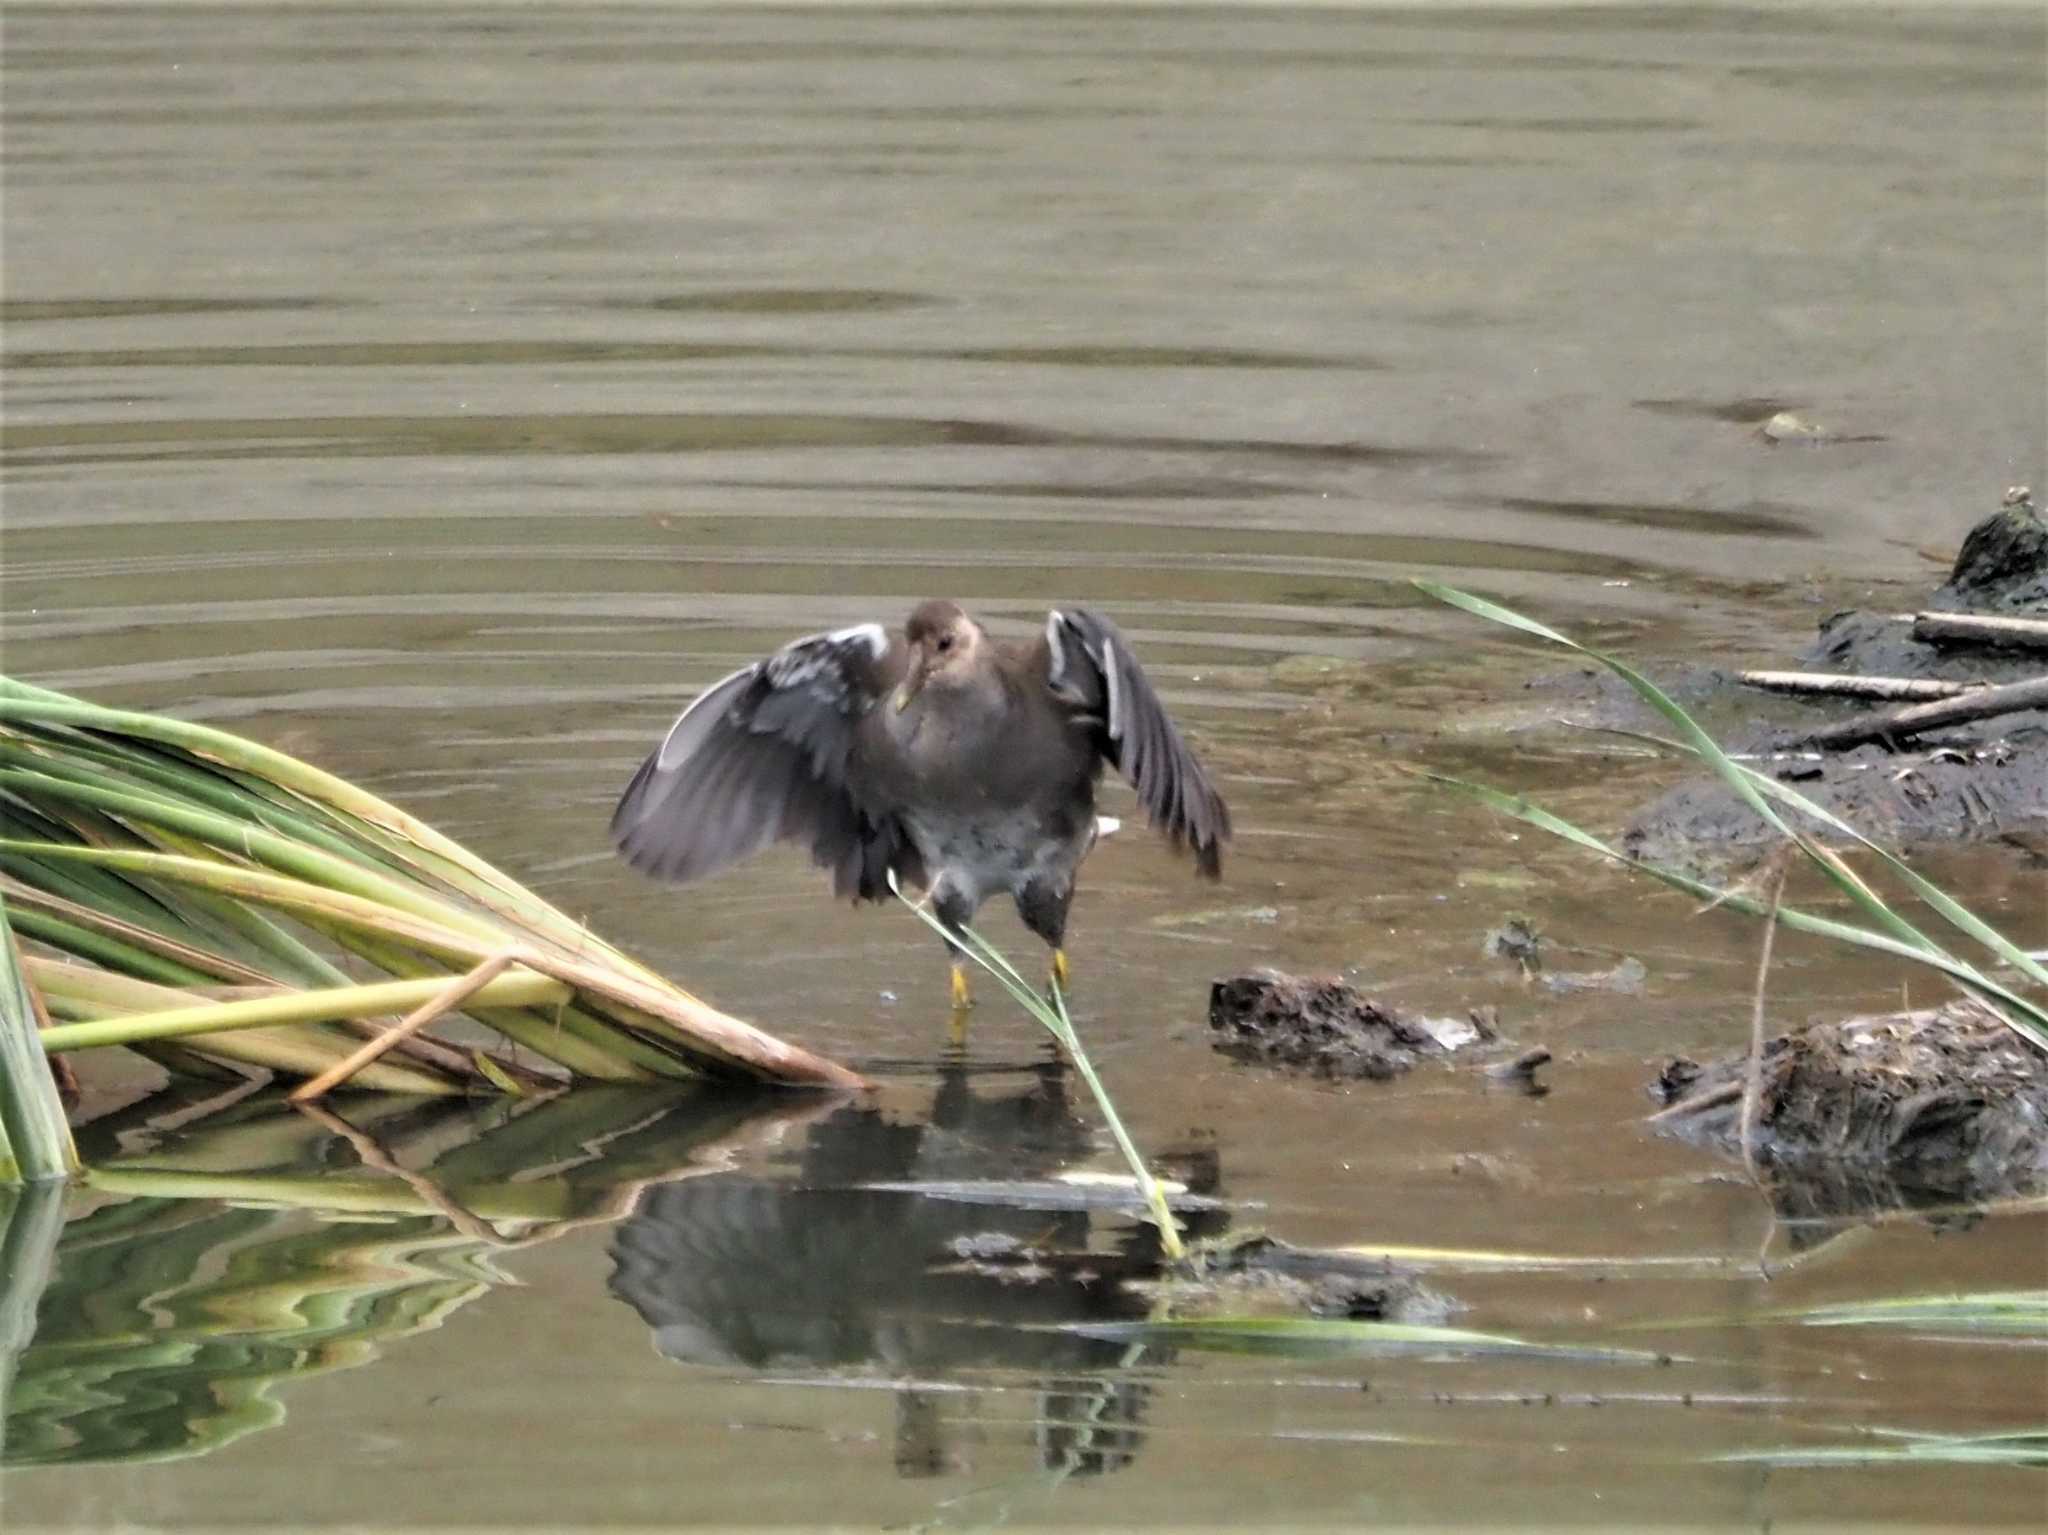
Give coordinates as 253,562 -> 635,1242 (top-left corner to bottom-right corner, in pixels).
1044,608 -> 1231,878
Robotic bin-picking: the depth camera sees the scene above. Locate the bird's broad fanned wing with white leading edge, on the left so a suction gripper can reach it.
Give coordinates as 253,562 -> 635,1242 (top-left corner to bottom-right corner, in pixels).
612,624 -> 918,898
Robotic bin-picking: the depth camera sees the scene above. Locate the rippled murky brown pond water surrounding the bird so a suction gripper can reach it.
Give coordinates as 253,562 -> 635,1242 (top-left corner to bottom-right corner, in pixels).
0,6 -> 2048,1527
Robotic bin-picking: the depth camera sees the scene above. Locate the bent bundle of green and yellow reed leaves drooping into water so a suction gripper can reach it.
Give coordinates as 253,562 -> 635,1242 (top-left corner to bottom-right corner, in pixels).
0,677 -> 862,1091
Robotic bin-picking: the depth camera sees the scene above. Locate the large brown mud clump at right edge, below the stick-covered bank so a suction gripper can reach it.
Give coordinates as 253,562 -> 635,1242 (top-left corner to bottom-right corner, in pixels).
1655,1001 -> 2048,1216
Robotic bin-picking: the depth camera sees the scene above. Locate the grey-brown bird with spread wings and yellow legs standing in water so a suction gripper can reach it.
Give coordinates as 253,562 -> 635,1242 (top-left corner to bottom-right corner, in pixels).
610,600 -> 1231,1023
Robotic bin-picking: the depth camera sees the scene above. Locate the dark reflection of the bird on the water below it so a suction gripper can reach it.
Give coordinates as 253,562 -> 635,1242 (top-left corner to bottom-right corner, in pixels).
612,1062 -> 1225,1476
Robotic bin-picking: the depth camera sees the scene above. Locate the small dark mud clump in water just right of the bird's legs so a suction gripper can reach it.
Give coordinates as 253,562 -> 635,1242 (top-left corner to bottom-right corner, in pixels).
1208,970 -> 1499,1081
